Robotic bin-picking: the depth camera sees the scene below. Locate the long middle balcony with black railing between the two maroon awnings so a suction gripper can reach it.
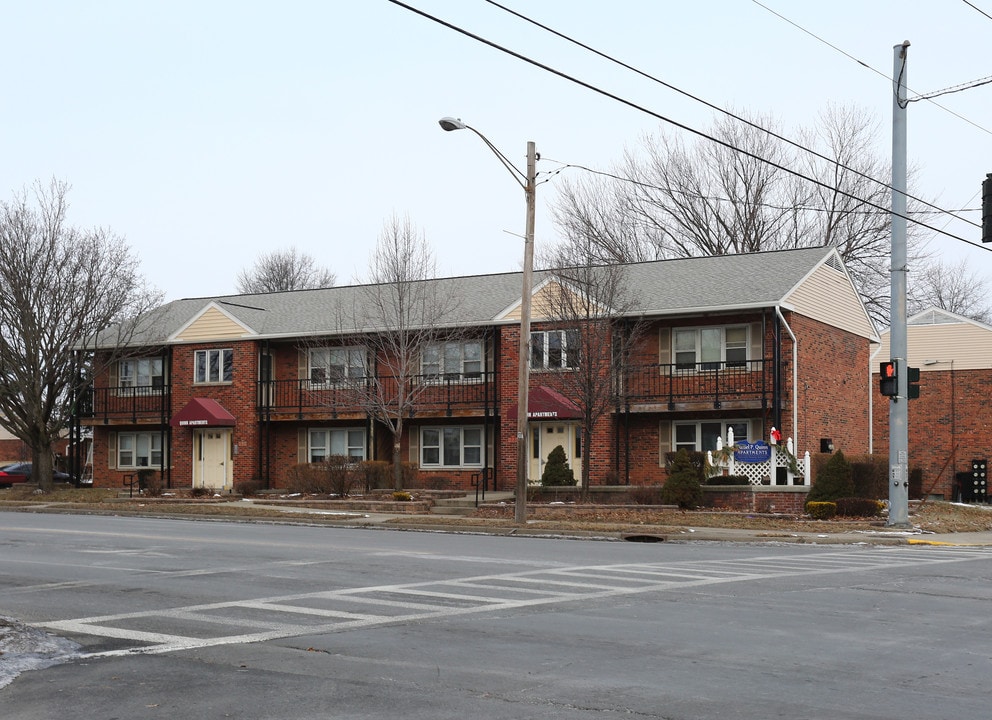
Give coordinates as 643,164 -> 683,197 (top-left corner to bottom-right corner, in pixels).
257,372 -> 496,419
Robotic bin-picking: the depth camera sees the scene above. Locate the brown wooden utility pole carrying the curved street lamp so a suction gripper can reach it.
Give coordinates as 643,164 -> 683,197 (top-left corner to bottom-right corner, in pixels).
513,142 -> 537,524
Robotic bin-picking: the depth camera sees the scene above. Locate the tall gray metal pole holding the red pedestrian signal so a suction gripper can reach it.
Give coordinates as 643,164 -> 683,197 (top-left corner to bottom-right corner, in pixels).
886,40 -> 909,527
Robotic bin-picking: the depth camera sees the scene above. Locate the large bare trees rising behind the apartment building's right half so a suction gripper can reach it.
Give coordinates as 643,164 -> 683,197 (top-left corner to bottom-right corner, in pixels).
554,102 -> 924,323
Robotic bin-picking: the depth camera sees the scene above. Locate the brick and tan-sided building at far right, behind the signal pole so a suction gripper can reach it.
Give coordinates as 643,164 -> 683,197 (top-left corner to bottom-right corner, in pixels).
872,308 -> 992,500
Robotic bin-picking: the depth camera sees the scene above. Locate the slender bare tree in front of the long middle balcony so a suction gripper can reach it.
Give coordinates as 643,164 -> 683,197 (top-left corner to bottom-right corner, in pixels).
355,216 -> 458,490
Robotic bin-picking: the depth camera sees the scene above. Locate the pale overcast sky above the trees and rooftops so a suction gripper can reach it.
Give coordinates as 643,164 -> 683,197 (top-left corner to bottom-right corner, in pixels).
0,0 -> 992,299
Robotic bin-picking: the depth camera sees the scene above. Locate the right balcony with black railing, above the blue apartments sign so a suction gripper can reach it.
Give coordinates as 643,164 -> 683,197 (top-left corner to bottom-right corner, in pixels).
621,360 -> 772,412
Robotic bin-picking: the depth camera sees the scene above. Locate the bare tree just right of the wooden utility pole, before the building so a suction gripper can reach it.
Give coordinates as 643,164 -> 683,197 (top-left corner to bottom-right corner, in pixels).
536,241 -> 643,497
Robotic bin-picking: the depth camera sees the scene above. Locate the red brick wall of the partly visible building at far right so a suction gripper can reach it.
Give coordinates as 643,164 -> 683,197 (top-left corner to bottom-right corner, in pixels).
872,366 -> 992,500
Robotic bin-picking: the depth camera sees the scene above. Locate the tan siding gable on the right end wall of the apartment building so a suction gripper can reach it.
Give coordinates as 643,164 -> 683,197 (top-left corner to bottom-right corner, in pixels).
785,264 -> 875,338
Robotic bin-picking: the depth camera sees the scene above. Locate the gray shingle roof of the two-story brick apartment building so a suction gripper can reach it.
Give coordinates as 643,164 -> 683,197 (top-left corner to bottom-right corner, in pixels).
118,247 -> 836,345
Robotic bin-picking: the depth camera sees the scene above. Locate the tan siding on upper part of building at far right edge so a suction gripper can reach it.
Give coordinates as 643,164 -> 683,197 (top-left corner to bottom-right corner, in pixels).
872,322 -> 992,373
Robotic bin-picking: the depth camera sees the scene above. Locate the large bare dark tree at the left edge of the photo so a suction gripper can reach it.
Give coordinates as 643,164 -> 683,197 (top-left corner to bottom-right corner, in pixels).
0,180 -> 160,489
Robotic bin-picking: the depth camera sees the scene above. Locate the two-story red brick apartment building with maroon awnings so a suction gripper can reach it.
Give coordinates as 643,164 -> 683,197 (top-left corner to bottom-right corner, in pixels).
71,248 -> 878,489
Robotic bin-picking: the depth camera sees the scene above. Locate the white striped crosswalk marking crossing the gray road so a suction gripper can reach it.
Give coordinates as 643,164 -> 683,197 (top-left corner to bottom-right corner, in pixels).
35,547 -> 992,659
